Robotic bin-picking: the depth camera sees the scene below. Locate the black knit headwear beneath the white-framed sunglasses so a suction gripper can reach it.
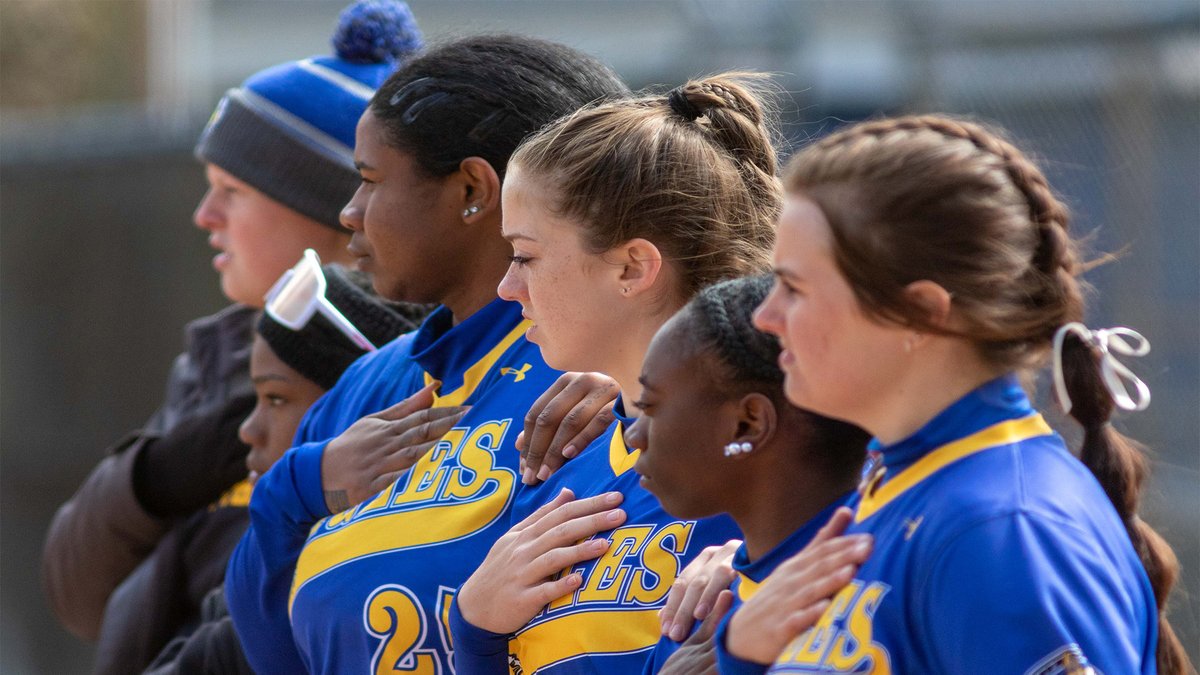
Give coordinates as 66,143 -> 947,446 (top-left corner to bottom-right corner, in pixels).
258,264 -> 428,389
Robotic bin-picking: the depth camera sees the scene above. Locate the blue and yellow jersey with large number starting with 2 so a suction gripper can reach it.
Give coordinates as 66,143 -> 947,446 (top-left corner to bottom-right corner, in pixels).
227,300 -> 560,673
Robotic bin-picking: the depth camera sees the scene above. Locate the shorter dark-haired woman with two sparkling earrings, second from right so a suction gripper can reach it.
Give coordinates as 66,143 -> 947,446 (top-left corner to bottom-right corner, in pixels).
625,275 -> 870,673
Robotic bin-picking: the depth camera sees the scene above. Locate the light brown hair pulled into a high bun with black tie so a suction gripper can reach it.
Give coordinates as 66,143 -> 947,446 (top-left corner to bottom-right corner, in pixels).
511,73 -> 782,300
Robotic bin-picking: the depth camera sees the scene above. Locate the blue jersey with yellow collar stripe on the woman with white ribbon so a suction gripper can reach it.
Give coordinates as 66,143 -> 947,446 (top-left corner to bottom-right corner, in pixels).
769,376 -> 1158,675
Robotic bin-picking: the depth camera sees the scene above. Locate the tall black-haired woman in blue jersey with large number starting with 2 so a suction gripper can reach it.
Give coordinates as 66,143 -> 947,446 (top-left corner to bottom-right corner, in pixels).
226,36 -> 628,673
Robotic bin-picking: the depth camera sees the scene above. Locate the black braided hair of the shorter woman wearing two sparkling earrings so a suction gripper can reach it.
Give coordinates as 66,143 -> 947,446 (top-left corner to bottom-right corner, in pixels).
672,274 -> 869,482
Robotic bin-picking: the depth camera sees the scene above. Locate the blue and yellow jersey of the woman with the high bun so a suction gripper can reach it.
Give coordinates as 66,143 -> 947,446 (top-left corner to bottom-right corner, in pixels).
451,400 -> 740,675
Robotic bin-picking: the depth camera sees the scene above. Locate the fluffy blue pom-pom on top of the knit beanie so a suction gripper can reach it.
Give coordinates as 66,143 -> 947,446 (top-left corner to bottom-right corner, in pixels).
334,0 -> 424,64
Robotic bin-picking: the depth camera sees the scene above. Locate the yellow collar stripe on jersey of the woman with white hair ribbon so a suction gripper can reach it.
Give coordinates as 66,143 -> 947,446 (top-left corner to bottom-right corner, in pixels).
854,413 -> 1054,522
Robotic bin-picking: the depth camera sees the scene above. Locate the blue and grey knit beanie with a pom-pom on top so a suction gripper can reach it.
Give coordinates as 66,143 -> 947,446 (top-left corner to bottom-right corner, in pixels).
196,0 -> 422,229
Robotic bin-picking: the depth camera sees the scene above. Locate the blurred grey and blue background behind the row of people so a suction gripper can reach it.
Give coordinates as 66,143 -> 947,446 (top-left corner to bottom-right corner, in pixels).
0,0 -> 1200,674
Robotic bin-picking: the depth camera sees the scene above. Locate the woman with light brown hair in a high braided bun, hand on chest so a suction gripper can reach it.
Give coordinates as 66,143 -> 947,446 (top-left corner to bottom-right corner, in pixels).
451,76 -> 781,673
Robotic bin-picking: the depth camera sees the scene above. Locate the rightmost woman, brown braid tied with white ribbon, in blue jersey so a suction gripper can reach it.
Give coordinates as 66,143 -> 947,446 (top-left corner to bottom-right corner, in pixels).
739,117 -> 1189,674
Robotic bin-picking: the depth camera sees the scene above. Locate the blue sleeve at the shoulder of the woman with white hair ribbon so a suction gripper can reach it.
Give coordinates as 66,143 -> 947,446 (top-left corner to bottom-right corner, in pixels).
914,512 -> 1153,675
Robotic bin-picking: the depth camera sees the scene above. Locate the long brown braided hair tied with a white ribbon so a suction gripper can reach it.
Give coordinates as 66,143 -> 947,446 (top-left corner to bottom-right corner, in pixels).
785,115 -> 1187,673
